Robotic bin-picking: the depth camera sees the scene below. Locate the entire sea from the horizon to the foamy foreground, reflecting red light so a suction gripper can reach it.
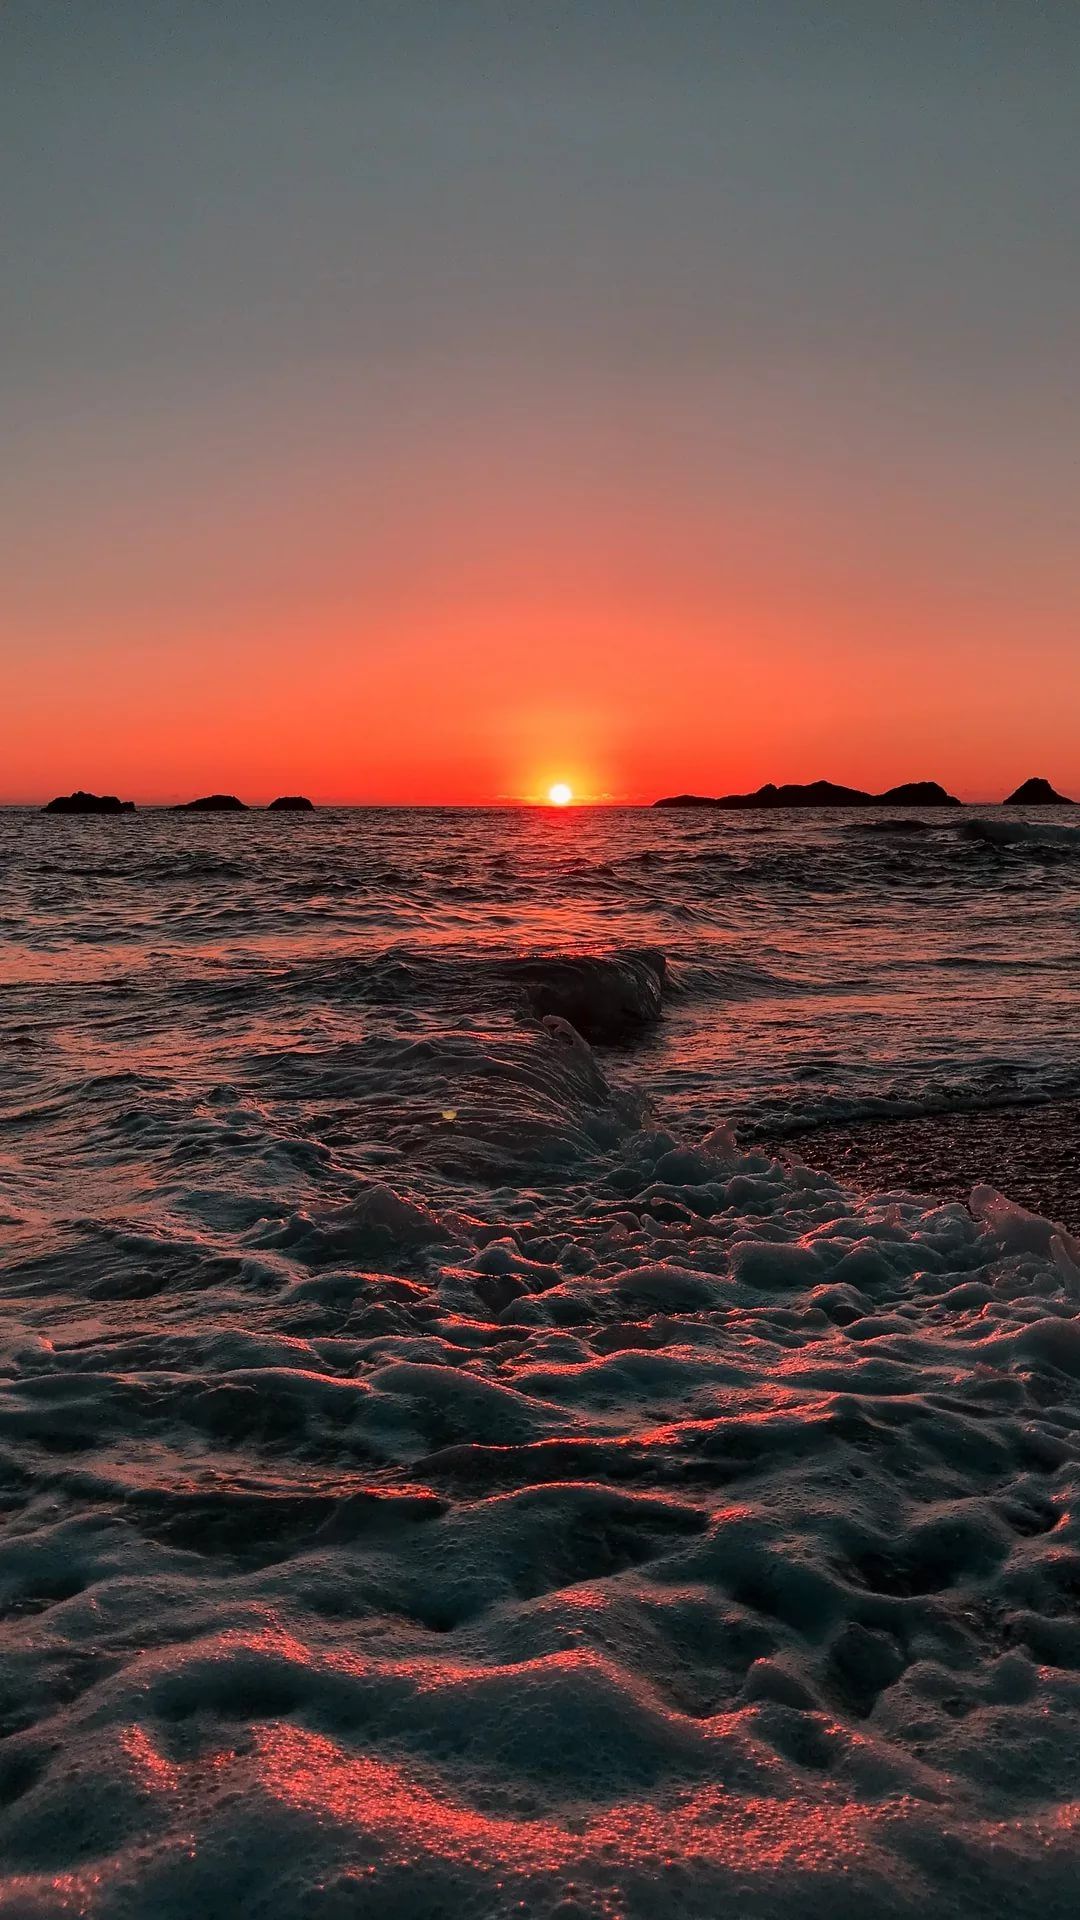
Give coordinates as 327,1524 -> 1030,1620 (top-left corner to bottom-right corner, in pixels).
0,808 -> 1080,1920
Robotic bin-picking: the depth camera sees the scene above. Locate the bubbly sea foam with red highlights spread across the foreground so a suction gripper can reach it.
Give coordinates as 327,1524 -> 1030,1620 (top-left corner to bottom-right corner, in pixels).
0,1105 -> 1080,1916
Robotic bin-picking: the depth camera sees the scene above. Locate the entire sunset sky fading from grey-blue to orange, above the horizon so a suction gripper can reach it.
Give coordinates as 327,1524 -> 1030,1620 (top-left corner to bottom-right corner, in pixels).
0,0 -> 1080,803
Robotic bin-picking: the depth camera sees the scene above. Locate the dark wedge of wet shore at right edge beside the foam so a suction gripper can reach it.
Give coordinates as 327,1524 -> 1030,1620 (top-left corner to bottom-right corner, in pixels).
765,1100 -> 1080,1233
